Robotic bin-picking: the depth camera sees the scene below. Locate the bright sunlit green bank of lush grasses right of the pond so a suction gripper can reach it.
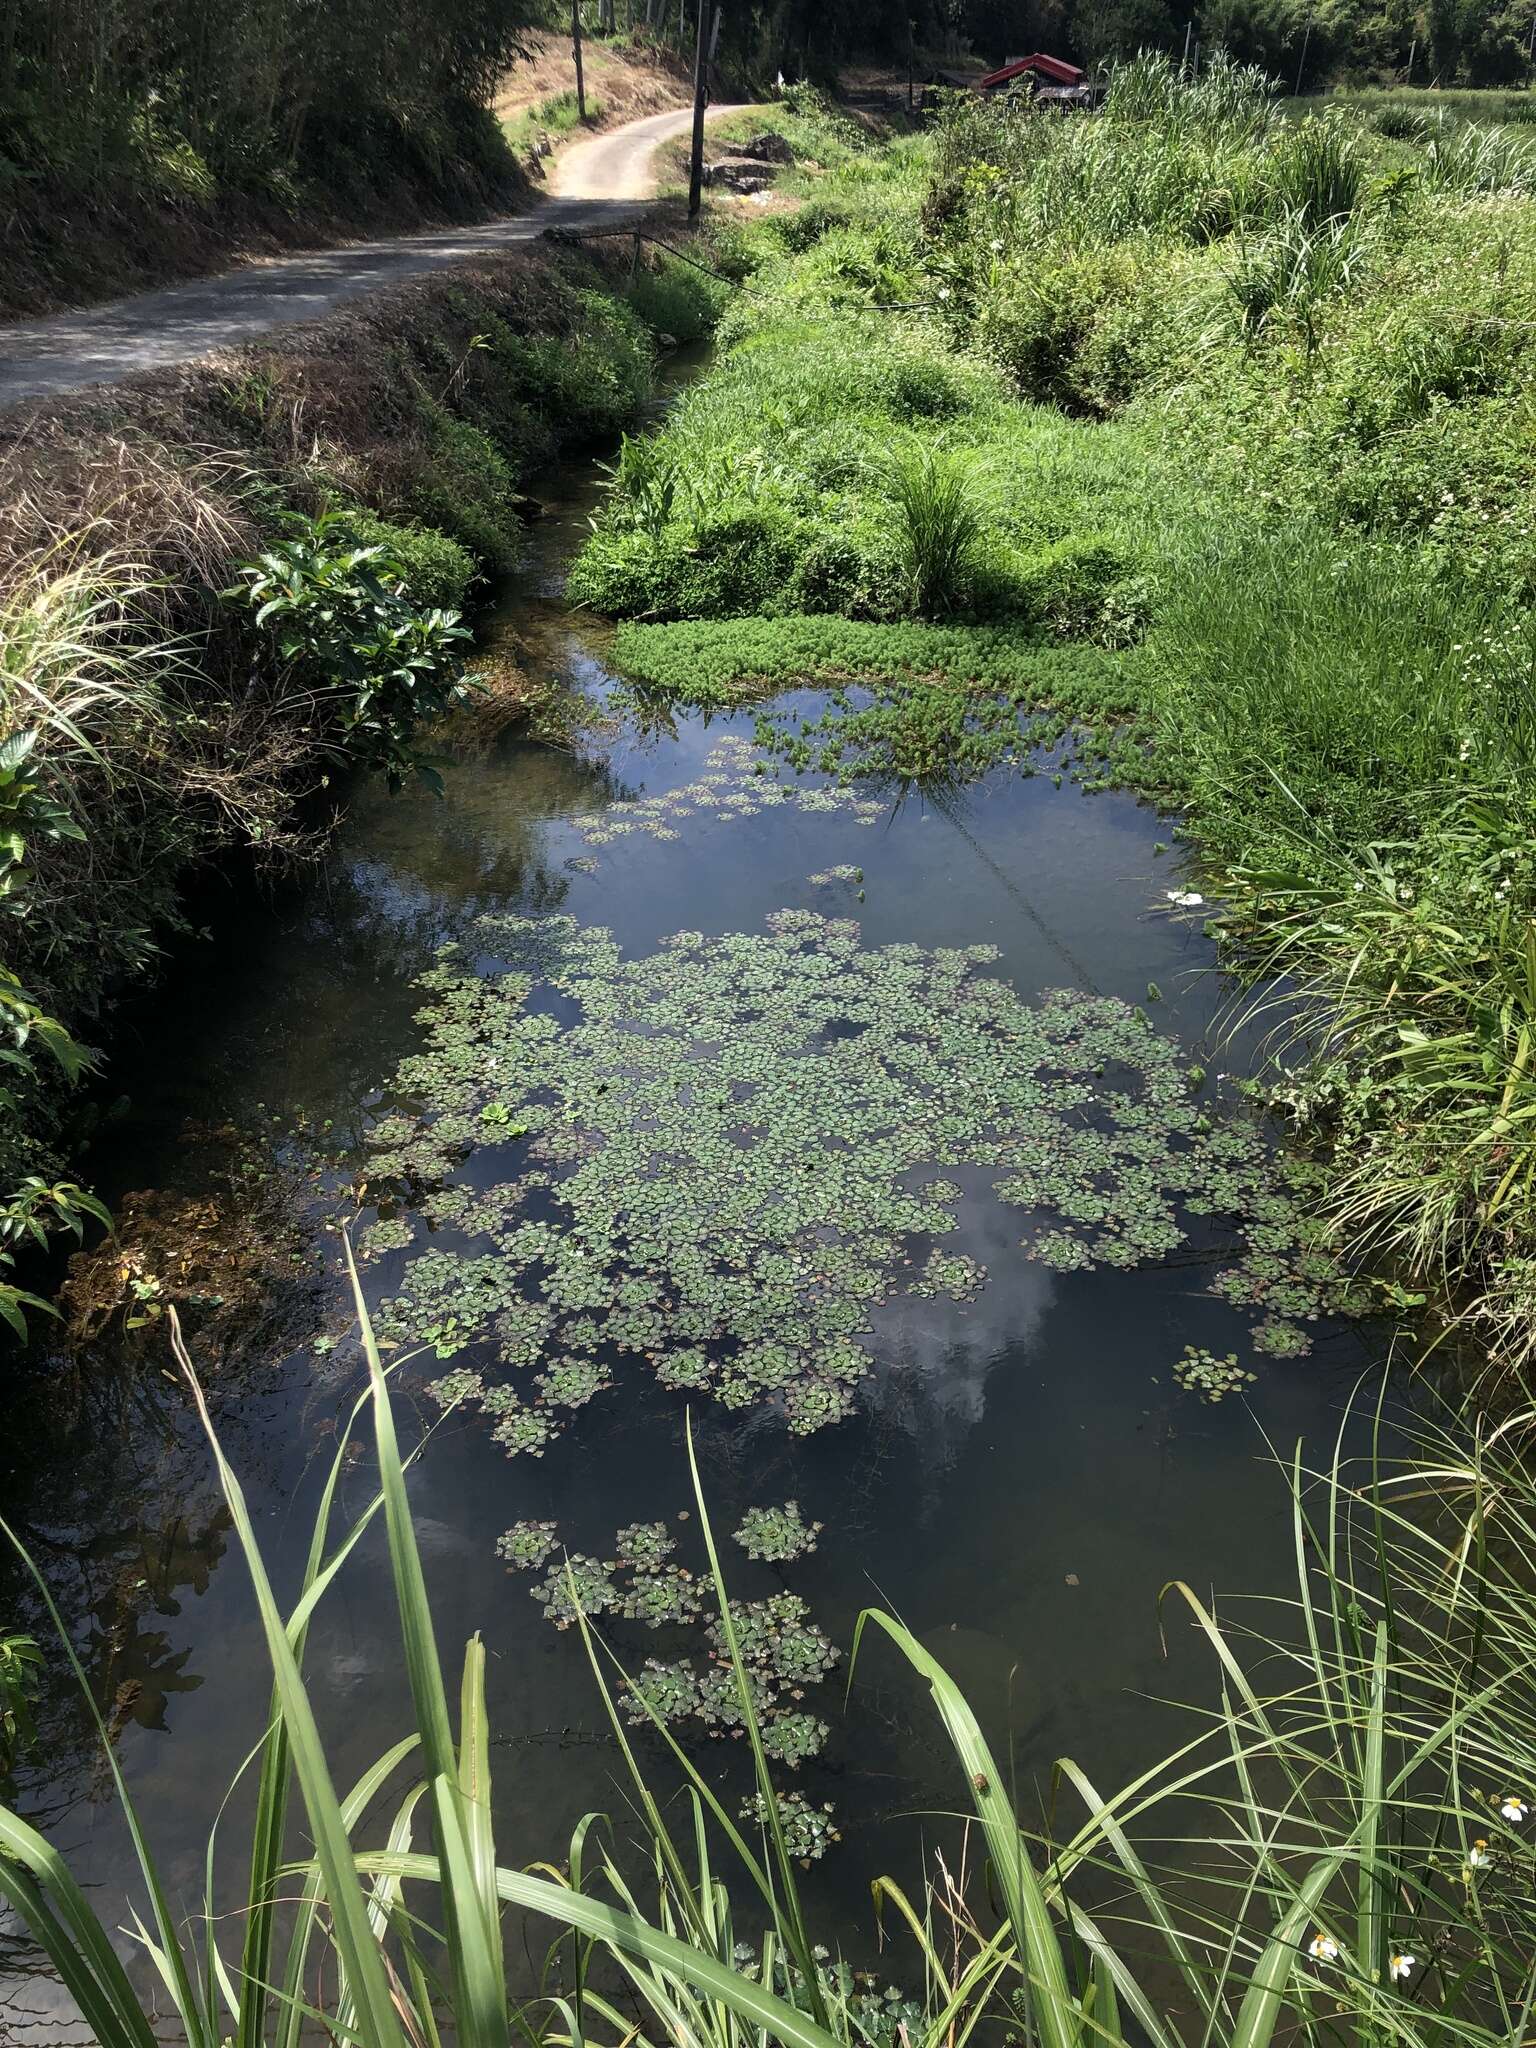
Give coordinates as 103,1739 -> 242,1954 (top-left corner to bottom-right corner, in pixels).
571,61 -> 1536,1356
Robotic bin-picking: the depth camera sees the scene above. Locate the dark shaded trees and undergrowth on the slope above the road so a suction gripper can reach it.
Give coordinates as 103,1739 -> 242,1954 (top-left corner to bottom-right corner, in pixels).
0,0 -> 526,317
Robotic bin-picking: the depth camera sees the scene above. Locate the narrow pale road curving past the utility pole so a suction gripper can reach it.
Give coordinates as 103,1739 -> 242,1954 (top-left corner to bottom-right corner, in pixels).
0,106 -> 735,408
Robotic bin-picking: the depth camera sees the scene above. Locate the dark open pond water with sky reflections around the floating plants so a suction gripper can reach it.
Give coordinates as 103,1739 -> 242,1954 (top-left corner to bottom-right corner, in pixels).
6,372 -> 1368,2015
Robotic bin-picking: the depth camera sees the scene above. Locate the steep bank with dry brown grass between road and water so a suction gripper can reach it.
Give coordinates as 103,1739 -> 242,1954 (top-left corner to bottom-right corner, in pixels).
0,235 -> 719,1323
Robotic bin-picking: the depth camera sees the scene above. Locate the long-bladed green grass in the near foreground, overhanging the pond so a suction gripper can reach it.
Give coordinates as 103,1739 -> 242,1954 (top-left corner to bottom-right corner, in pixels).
0,1272 -> 1536,2048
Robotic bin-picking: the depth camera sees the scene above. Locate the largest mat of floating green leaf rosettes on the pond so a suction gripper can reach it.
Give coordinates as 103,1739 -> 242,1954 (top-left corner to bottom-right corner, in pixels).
365,911 -> 1368,1454
